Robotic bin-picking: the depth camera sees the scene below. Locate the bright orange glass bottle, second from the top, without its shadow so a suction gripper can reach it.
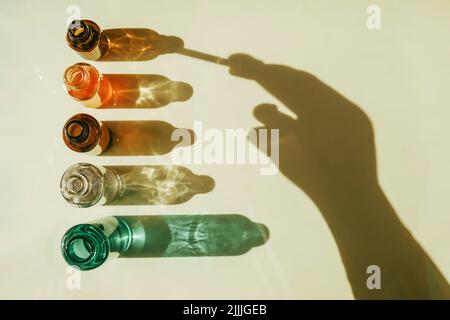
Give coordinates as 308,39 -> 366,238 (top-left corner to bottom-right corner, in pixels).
64,63 -> 112,108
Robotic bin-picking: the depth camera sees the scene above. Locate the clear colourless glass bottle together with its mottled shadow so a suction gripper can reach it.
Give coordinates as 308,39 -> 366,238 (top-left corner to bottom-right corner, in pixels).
60,163 -> 214,208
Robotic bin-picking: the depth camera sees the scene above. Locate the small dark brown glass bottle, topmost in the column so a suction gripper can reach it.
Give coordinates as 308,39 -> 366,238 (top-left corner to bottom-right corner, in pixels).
66,20 -> 104,60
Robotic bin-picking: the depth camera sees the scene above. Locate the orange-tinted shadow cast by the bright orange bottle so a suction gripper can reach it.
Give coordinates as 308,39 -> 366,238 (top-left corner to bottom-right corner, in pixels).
99,74 -> 193,109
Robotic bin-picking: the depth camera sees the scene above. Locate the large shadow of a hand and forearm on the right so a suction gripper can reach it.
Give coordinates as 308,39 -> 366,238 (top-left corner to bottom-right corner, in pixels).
228,54 -> 450,299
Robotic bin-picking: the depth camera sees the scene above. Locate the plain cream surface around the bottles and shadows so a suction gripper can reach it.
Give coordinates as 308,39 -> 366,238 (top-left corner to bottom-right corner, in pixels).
0,0 -> 450,299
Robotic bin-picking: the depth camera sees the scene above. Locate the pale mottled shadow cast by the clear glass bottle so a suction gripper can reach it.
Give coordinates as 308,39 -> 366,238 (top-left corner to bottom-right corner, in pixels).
105,165 -> 215,206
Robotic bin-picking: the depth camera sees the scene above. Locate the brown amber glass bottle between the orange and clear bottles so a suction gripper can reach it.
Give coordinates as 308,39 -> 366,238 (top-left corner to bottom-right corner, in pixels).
63,113 -> 110,155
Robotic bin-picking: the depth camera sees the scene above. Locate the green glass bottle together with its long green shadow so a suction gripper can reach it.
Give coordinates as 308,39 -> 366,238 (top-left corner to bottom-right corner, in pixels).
61,214 -> 269,270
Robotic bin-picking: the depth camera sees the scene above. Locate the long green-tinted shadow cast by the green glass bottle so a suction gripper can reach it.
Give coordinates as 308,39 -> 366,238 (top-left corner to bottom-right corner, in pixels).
117,214 -> 269,258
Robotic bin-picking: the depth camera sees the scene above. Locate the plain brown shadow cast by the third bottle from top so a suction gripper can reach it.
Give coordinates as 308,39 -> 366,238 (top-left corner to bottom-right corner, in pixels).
99,120 -> 195,156
